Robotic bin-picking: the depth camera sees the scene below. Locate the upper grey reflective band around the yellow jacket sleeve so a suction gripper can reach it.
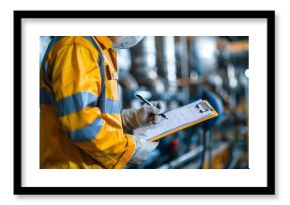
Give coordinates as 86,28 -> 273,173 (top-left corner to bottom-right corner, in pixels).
56,92 -> 98,117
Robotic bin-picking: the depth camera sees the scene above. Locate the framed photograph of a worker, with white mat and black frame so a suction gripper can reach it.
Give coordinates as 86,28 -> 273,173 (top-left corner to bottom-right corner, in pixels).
14,11 -> 275,195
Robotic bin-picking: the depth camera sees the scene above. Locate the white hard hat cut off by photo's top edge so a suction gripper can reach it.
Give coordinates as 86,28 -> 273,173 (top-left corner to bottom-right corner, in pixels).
110,36 -> 144,48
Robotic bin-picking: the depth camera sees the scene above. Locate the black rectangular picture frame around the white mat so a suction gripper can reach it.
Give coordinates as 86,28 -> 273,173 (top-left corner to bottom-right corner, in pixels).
14,11 -> 275,195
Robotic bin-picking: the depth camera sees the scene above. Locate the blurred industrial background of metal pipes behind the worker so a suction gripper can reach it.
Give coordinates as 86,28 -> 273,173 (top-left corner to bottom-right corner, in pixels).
40,36 -> 249,169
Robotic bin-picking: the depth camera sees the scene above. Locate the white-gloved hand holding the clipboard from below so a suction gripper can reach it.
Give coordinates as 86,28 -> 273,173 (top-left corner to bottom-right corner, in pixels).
129,134 -> 159,164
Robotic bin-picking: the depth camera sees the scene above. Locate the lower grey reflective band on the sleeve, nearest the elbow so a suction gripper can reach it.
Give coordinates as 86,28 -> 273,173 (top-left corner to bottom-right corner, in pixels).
67,117 -> 104,142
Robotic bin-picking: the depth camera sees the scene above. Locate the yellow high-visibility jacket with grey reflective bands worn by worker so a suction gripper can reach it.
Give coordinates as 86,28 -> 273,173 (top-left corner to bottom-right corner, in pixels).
40,36 -> 135,169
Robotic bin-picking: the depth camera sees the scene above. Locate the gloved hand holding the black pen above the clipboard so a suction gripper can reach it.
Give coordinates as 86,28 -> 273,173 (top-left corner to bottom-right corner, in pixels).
121,101 -> 166,129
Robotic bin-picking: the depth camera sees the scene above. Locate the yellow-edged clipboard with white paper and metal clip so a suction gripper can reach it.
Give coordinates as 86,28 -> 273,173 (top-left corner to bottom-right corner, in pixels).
134,99 -> 218,141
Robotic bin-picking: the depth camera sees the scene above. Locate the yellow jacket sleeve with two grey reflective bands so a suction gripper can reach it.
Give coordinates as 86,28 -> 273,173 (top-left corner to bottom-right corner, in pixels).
50,44 -> 135,168
